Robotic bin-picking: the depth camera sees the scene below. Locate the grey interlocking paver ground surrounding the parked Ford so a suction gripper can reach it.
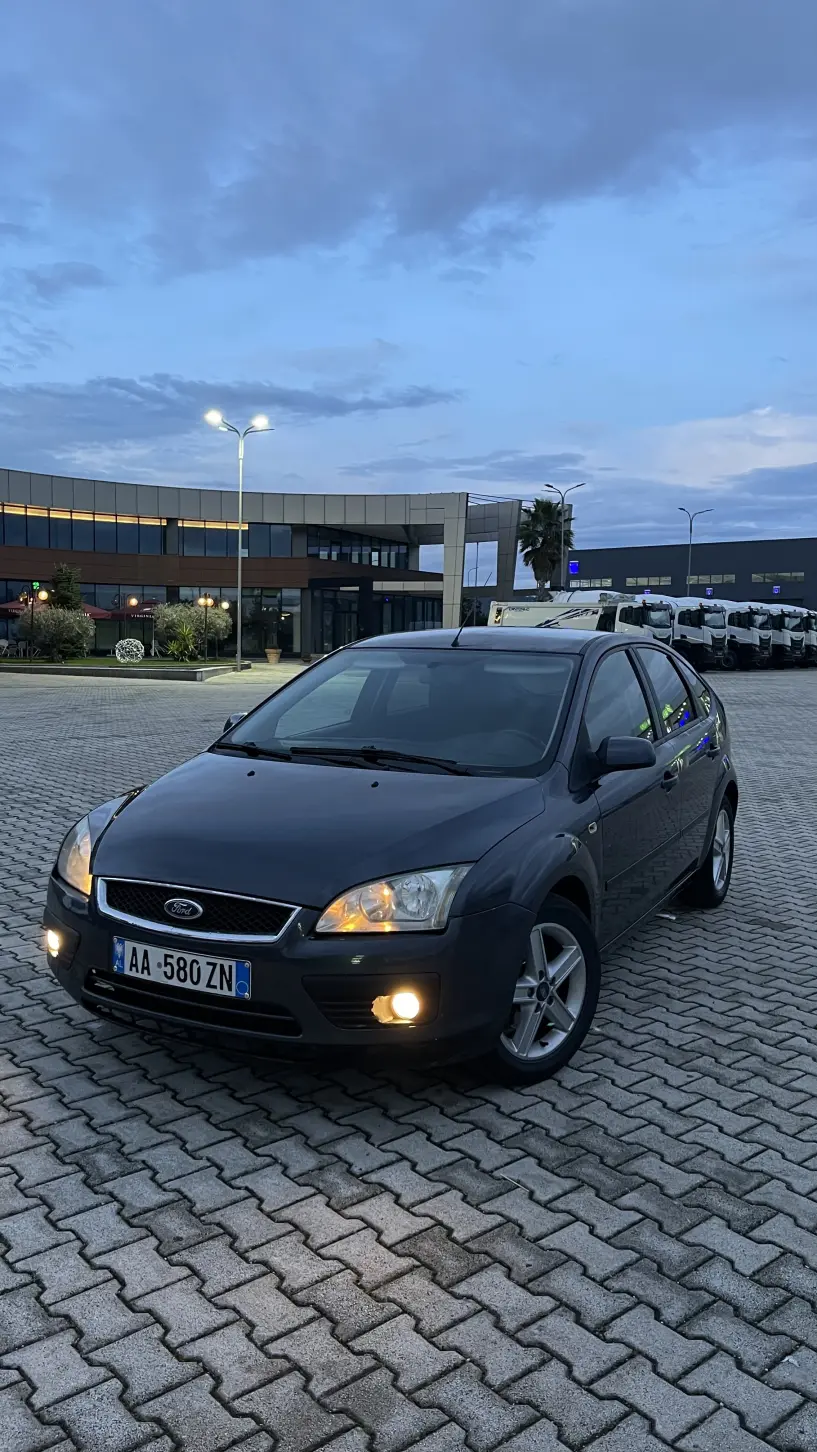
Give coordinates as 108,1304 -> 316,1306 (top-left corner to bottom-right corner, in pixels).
0,674 -> 817,1452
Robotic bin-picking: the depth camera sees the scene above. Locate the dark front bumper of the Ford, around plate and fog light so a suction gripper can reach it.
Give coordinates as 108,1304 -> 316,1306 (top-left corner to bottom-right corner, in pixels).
44,877 -> 534,1060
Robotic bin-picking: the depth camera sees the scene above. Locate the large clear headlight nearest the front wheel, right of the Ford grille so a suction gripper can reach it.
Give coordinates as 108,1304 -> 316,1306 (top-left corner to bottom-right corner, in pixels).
315,862 -> 470,932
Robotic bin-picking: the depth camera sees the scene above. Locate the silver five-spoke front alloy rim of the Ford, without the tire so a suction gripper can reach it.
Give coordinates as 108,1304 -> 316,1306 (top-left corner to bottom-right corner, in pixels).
501,922 -> 588,1063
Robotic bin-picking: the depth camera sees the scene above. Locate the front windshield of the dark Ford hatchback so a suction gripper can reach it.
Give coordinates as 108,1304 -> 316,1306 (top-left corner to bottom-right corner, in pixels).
223,646 -> 578,775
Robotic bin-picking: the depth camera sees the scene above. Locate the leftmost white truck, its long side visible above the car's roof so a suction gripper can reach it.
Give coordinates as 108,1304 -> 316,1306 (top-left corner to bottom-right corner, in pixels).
488,590 -> 672,645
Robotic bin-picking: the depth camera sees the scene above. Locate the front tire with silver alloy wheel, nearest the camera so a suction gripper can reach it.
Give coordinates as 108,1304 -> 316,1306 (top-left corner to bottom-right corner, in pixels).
493,894 -> 601,1085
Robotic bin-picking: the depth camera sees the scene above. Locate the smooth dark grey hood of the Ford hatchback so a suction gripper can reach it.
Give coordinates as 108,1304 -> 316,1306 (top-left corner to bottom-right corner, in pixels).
93,752 -> 544,908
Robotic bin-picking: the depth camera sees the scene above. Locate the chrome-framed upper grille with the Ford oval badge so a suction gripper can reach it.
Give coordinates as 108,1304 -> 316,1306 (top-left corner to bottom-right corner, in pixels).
99,878 -> 296,939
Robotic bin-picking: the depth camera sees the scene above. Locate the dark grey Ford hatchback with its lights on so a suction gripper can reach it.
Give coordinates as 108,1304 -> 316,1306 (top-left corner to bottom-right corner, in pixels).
45,629 -> 737,1082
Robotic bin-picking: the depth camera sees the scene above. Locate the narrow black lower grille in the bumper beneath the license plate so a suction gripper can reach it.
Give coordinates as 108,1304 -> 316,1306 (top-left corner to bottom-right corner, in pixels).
84,968 -> 300,1038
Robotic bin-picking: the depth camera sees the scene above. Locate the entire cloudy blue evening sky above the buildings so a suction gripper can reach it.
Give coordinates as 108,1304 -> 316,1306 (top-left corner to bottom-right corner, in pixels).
0,0 -> 817,589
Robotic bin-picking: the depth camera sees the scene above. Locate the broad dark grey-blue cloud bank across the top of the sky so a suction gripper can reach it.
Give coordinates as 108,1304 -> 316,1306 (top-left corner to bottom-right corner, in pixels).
3,0 -> 817,272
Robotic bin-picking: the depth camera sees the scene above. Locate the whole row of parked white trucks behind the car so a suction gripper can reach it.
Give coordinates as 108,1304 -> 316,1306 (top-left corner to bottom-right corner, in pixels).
488,590 -> 817,671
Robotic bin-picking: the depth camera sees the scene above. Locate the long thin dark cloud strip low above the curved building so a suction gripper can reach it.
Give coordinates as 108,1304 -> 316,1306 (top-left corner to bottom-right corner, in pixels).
0,373 -> 456,454
